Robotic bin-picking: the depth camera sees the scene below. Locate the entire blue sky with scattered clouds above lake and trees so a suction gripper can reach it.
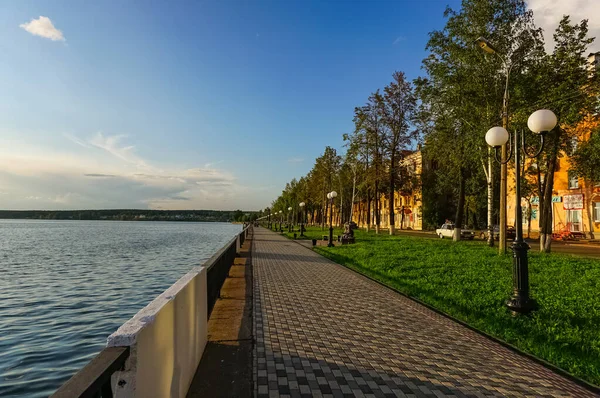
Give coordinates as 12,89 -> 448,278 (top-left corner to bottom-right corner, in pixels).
0,0 -> 600,210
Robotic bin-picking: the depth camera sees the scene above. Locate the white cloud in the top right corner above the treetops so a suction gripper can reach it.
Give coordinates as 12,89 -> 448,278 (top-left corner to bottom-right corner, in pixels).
527,0 -> 600,51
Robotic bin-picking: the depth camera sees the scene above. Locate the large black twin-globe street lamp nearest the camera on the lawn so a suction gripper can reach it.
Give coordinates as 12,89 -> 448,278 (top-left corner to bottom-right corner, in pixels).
485,109 -> 557,314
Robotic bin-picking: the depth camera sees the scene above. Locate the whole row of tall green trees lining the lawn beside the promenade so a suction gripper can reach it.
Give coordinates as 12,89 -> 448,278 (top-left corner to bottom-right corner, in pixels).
261,0 -> 600,251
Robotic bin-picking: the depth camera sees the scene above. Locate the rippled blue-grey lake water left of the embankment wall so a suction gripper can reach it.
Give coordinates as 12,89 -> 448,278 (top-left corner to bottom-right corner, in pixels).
0,220 -> 241,398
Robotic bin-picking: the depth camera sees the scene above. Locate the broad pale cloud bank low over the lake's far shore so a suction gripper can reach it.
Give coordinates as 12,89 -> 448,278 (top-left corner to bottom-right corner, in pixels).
0,133 -> 264,210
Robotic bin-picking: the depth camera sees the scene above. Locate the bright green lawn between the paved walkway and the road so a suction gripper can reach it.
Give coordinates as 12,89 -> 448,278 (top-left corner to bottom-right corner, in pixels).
286,227 -> 600,385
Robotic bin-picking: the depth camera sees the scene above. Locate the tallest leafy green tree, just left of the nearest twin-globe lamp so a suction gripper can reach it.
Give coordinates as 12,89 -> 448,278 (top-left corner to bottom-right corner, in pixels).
416,0 -> 542,240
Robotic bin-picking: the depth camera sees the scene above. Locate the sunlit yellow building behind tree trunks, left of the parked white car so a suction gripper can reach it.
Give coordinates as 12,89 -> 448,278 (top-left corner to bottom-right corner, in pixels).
352,148 -> 423,230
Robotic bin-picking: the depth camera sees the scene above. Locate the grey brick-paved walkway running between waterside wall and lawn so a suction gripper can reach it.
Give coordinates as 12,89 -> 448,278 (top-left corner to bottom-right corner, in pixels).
252,228 -> 594,397
